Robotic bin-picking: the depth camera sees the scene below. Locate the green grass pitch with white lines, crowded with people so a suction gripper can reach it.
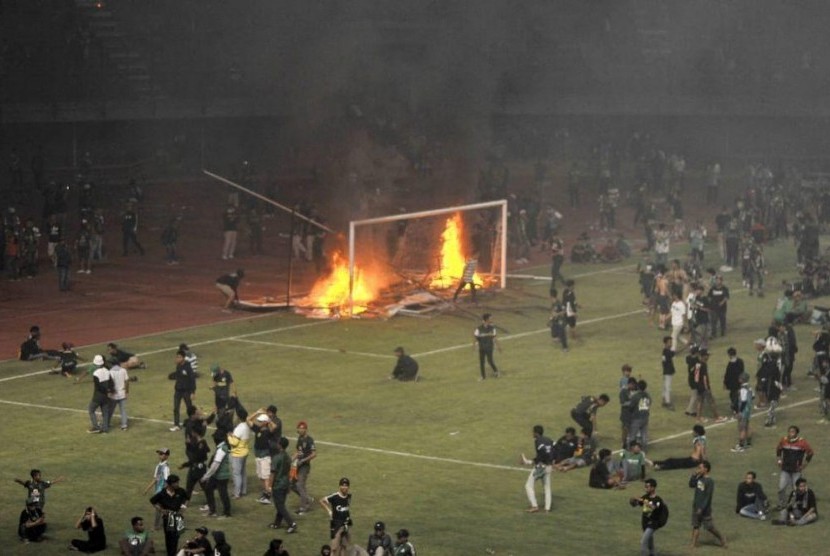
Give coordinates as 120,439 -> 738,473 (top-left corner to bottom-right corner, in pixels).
0,237 -> 830,556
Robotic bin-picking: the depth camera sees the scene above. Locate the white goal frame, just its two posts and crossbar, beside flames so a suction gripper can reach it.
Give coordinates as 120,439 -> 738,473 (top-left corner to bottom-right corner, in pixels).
349,199 -> 507,313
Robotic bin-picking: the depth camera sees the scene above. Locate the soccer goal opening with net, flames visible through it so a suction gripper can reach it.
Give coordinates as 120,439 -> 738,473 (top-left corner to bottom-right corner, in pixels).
348,200 -> 507,307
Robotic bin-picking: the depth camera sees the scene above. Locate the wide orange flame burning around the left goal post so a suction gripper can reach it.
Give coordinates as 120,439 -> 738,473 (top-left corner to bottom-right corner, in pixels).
307,251 -> 380,315
